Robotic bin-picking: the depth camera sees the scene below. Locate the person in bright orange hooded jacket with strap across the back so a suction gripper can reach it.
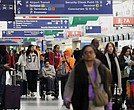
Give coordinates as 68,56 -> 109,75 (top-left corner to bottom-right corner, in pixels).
57,48 -> 75,99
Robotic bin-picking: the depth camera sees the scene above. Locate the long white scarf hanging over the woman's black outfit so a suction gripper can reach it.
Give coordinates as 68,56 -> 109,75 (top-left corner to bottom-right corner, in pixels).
105,53 -> 122,88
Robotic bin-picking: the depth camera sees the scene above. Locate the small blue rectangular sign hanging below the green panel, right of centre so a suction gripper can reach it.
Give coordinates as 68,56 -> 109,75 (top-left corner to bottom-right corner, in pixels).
86,26 -> 101,33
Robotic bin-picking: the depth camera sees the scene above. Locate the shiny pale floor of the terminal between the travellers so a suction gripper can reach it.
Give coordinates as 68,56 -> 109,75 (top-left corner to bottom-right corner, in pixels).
7,72 -> 72,110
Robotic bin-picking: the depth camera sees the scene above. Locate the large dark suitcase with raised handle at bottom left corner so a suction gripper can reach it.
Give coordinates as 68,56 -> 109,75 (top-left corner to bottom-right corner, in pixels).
4,69 -> 20,109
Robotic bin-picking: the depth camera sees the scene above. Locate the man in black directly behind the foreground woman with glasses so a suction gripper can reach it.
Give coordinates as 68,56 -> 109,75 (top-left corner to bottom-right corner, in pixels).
91,38 -> 108,67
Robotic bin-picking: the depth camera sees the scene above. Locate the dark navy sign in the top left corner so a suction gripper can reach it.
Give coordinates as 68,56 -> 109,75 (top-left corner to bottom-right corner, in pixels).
0,0 -> 15,21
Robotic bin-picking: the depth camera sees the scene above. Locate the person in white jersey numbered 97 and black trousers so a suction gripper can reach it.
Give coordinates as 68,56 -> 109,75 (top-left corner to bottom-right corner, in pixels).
25,45 -> 40,97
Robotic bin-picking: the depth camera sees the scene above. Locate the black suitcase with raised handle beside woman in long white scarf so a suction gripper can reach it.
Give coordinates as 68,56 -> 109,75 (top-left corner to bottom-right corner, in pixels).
112,86 -> 122,110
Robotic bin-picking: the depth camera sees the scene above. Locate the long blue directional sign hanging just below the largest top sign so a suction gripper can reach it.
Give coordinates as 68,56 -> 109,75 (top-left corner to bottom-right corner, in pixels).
7,19 -> 69,29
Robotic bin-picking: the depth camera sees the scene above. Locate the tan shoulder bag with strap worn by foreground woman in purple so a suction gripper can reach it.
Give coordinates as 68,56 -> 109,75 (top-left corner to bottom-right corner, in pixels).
89,74 -> 108,106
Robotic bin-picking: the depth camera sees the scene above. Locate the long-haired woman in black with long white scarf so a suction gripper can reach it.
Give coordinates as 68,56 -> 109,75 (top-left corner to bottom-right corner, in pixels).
104,42 -> 122,94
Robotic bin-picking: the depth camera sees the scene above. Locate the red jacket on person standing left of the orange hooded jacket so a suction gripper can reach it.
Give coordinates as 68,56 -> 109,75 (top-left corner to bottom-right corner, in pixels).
48,52 -> 61,69
